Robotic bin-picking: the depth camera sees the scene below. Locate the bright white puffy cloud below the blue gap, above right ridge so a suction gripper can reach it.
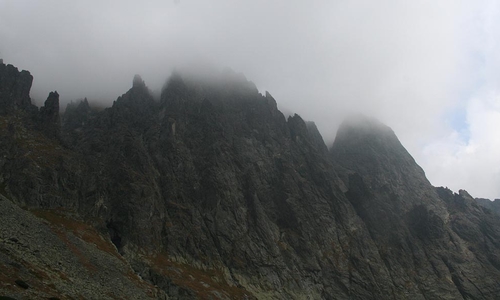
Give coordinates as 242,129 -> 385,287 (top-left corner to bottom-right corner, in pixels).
423,93 -> 500,199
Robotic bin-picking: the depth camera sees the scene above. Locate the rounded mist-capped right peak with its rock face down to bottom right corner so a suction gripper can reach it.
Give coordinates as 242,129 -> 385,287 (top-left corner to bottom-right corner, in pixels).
331,118 -> 500,299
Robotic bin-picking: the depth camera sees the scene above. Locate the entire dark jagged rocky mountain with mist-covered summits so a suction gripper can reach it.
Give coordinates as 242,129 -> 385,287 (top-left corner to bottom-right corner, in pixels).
0,59 -> 500,299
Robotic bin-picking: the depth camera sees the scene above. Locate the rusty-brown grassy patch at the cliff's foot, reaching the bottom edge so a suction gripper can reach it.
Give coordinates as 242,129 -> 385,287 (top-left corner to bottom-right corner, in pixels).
146,254 -> 254,299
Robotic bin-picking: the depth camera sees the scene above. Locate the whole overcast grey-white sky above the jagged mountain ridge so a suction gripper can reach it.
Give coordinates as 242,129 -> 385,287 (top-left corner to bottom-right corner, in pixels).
0,0 -> 500,199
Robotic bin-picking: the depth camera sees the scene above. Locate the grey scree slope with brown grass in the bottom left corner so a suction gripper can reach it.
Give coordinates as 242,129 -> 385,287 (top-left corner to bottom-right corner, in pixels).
0,196 -> 162,299
